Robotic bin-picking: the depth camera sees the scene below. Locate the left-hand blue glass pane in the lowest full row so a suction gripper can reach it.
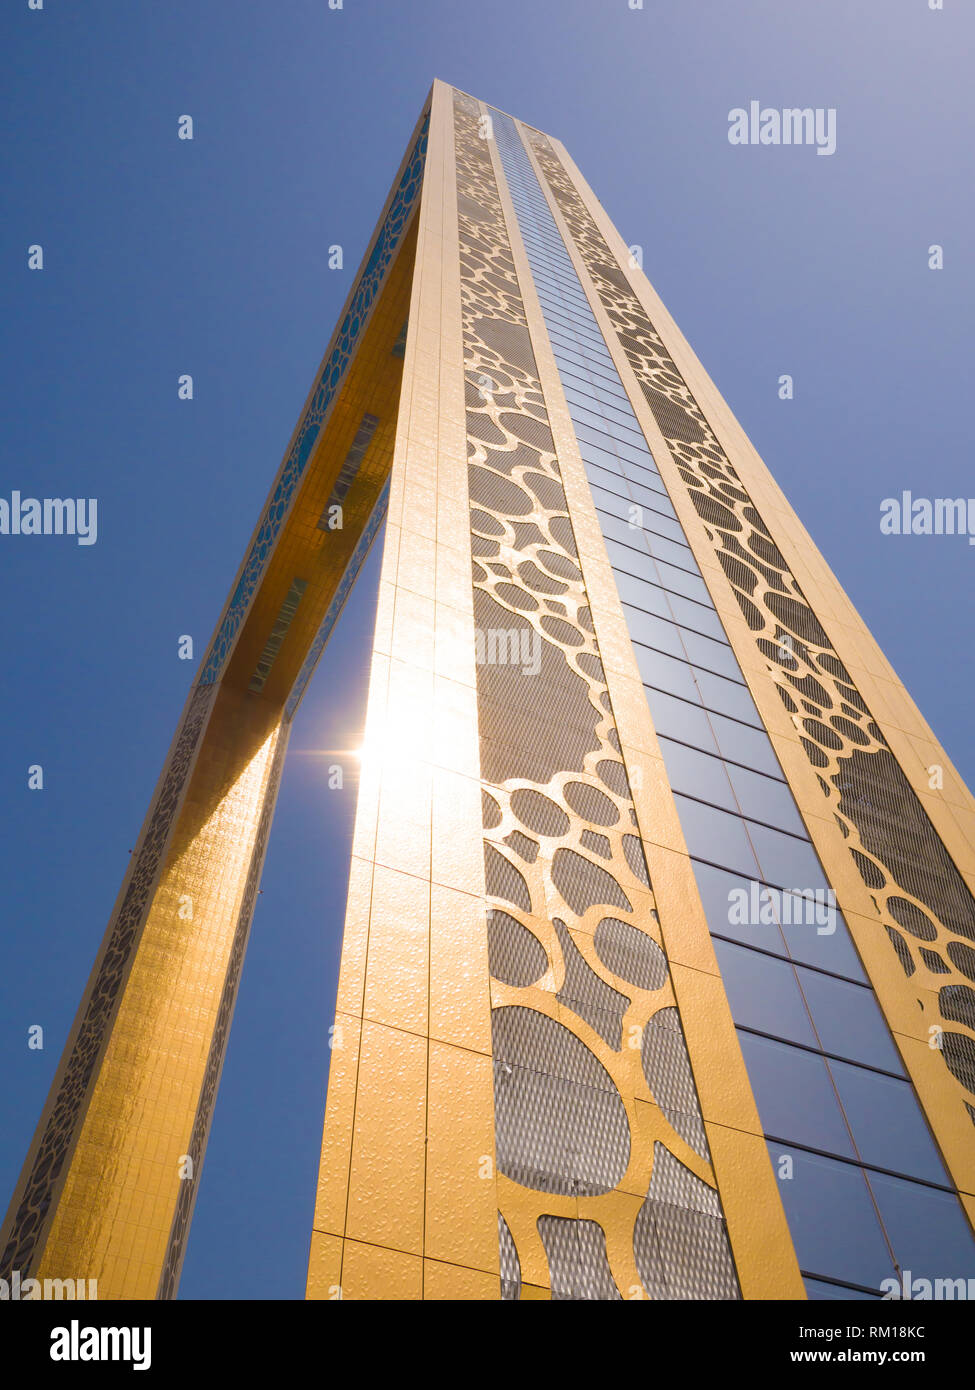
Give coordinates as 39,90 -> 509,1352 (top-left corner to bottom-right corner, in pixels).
769,1144 -> 892,1290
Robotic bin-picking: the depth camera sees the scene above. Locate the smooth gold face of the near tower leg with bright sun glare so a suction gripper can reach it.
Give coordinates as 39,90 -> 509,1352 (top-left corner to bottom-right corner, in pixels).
307,82 -> 499,1300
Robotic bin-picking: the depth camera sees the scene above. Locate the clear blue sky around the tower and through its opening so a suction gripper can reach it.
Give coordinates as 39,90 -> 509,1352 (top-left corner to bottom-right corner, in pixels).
0,0 -> 975,1298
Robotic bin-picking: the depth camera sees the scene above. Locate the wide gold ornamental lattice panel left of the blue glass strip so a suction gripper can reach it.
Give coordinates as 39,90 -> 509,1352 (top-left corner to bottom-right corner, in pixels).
453,93 -> 740,1300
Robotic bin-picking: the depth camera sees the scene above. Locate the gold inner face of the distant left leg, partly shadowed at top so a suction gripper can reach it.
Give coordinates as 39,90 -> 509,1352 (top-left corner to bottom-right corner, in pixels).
38,691 -> 281,1298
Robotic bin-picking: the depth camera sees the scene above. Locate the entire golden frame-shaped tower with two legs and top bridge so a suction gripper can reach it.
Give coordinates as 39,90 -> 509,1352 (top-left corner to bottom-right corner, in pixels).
0,82 -> 975,1300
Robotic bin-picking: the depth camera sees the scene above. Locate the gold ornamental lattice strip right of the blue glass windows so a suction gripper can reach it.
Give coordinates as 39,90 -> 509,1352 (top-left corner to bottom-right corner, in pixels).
526,129 -> 975,1122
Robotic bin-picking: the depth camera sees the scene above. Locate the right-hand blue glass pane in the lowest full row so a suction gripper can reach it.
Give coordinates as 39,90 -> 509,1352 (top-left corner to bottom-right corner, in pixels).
871,1173 -> 975,1280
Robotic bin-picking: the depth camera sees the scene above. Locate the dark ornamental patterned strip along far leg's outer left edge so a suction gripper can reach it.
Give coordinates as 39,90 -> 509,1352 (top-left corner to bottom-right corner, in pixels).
0,685 -> 217,1280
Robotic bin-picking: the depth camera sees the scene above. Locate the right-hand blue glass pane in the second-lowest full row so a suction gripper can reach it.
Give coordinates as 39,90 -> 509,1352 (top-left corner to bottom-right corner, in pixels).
829,1061 -> 949,1183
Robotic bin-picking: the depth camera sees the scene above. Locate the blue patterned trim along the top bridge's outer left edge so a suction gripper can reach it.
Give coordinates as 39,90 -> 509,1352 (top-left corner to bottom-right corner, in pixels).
199,117 -> 430,685
